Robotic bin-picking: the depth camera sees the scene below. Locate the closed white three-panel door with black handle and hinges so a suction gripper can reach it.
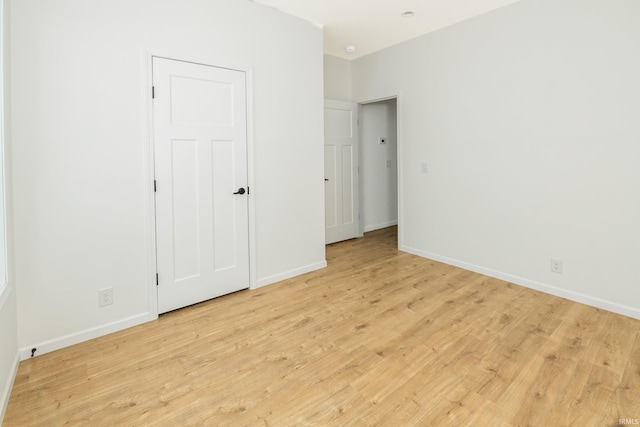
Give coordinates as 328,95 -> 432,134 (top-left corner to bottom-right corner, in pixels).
153,58 -> 249,313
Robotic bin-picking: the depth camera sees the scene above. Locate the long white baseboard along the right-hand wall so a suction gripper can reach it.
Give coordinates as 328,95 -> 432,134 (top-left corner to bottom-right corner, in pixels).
400,246 -> 640,320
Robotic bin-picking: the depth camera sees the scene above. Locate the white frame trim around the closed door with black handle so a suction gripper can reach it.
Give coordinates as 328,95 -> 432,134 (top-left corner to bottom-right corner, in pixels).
142,50 -> 257,320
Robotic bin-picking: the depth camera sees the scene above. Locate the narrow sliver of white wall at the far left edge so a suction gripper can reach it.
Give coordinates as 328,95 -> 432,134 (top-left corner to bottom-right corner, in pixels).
0,0 -> 18,424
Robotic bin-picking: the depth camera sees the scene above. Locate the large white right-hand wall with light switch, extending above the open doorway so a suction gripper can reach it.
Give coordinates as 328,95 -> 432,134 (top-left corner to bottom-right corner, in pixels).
352,0 -> 640,318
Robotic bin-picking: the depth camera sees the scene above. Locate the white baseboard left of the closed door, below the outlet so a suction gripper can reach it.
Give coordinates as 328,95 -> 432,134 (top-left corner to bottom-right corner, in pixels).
20,313 -> 157,360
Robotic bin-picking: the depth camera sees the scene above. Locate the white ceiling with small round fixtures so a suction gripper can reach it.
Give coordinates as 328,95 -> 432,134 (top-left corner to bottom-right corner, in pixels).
253,0 -> 519,59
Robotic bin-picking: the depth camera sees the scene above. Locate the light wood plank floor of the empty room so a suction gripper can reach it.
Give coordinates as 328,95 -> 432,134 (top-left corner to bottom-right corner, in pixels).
4,228 -> 640,427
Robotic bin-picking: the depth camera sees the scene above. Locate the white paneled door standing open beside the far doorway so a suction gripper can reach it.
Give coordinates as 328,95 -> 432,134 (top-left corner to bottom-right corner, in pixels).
324,100 -> 361,244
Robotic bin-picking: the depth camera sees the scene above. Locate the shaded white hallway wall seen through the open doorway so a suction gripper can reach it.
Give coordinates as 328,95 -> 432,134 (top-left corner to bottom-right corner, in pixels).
360,99 -> 398,232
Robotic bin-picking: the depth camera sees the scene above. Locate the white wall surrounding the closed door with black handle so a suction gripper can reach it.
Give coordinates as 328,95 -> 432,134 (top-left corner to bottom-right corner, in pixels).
11,0 -> 326,355
